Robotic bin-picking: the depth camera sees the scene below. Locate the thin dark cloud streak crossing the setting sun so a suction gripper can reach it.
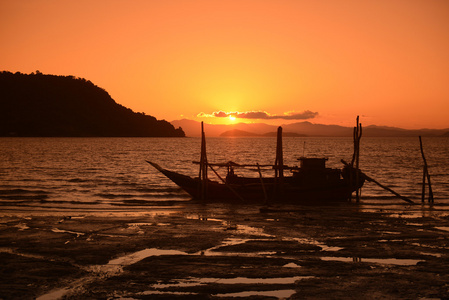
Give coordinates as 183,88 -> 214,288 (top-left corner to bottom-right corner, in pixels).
197,110 -> 318,120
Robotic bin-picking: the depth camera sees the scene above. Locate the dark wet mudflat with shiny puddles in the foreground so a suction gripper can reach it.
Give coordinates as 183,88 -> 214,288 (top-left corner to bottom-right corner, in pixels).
0,204 -> 449,299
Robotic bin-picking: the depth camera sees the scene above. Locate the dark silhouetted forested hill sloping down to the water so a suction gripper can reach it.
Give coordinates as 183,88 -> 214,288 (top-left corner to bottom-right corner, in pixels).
0,72 -> 185,137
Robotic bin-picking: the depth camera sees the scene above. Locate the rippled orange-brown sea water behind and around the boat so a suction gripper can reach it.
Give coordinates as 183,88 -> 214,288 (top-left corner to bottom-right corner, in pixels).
0,138 -> 449,213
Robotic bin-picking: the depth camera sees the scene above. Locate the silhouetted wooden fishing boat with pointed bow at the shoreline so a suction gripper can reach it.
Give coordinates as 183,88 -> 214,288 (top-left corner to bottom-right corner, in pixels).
148,123 -> 364,205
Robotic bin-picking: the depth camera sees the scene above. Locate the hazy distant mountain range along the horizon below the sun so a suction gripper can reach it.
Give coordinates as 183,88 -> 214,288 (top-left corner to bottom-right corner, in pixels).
171,119 -> 449,137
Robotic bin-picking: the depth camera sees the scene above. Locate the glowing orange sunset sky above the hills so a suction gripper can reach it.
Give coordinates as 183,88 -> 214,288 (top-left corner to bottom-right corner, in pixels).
0,0 -> 449,128
